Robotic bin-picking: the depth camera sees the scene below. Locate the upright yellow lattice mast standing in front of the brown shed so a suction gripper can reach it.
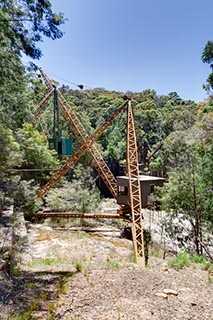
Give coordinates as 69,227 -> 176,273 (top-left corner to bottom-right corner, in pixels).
126,100 -> 145,266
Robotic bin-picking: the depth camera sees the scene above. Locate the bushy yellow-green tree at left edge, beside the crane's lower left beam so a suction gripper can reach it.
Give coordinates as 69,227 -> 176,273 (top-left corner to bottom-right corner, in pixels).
0,123 -> 59,207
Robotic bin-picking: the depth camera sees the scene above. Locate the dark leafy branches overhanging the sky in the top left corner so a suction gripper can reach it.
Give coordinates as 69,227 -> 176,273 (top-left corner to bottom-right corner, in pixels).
0,0 -> 64,59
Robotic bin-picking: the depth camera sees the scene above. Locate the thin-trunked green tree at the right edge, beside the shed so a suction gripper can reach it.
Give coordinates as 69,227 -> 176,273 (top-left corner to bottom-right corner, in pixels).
161,117 -> 213,254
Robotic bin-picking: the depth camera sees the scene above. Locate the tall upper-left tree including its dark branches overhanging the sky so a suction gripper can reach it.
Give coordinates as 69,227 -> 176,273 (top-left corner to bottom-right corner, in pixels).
0,0 -> 64,128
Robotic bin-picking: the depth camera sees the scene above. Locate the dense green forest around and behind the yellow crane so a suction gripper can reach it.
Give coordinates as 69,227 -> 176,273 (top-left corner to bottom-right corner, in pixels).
0,0 -> 213,253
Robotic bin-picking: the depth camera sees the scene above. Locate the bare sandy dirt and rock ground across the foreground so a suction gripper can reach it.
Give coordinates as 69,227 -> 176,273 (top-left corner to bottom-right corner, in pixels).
0,215 -> 213,320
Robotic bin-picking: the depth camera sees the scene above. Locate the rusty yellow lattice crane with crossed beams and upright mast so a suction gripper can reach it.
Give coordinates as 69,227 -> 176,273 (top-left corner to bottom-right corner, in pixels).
32,69 -> 145,266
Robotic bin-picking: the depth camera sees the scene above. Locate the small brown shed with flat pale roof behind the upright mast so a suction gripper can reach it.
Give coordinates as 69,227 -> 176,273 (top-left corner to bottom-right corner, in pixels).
117,175 -> 165,208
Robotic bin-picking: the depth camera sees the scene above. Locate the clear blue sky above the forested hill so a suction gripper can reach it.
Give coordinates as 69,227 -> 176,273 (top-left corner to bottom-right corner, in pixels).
37,0 -> 213,101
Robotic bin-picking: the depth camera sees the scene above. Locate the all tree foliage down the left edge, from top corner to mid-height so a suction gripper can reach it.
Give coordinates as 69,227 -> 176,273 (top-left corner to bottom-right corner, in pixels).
0,0 -> 64,210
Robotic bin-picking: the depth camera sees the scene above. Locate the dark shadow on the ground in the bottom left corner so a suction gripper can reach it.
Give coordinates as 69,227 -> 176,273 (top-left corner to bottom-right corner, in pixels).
0,271 -> 77,320
